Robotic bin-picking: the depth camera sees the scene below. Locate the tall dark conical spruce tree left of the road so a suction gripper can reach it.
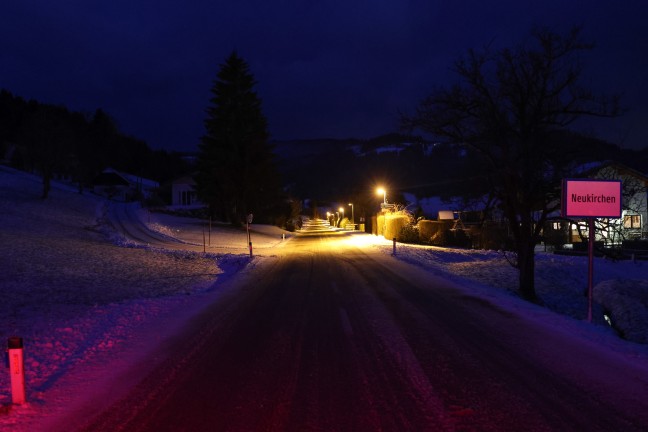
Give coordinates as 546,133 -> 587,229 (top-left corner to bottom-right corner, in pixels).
195,52 -> 280,225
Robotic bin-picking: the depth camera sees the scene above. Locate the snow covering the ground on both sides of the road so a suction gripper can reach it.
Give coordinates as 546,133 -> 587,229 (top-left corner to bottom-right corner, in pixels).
0,166 -> 648,431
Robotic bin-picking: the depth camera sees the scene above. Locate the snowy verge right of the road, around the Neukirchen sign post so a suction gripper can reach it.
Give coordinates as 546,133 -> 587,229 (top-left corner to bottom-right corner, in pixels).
360,235 -> 648,343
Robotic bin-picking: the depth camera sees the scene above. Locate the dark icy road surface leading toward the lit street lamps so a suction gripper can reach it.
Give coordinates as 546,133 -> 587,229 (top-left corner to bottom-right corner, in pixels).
67,233 -> 648,431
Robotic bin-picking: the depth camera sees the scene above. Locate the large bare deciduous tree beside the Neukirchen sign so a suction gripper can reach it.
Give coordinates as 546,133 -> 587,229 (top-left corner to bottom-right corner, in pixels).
402,28 -> 618,301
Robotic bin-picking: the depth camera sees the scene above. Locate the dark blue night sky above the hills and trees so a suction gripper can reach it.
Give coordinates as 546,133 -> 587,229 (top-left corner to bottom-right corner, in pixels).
0,0 -> 648,150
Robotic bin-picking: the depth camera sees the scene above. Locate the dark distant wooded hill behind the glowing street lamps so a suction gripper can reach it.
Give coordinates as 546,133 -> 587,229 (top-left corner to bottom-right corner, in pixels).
273,132 -> 648,208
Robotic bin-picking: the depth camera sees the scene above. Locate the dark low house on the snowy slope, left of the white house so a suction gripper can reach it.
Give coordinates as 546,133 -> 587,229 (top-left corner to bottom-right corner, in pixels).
93,168 -> 160,201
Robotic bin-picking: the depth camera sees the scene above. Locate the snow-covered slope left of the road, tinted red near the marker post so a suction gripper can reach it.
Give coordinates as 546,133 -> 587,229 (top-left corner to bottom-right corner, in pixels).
0,166 -> 282,430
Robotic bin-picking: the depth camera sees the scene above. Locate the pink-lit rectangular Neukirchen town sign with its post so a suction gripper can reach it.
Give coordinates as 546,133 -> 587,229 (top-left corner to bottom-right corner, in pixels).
562,179 -> 622,322
